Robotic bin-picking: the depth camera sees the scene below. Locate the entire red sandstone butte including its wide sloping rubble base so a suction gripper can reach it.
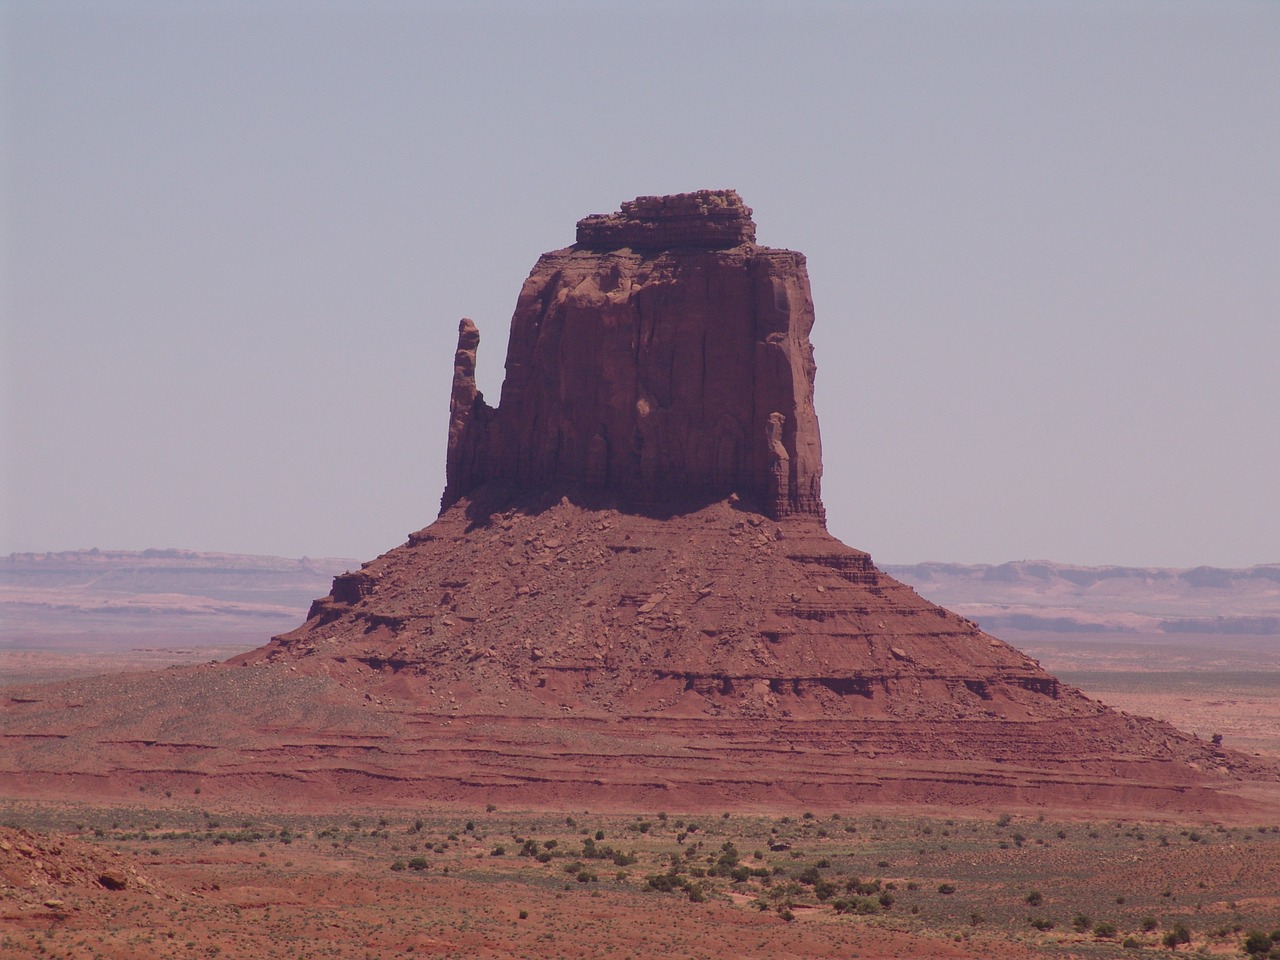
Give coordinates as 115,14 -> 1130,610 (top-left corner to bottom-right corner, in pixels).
0,191 -> 1276,815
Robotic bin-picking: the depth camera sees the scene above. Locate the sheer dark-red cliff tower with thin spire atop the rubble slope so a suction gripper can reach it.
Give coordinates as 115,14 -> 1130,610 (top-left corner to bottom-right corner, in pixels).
443,191 -> 823,518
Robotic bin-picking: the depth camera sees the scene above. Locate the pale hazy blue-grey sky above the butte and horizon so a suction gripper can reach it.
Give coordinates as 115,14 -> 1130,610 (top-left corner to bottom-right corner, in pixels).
0,0 -> 1280,566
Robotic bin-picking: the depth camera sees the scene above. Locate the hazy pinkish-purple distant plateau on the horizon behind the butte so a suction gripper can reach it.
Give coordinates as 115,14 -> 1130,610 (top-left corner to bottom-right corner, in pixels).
0,549 -> 1280,645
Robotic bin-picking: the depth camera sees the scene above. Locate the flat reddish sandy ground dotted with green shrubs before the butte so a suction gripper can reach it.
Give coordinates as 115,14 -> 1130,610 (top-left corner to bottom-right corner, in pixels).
0,804 -> 1280,960
